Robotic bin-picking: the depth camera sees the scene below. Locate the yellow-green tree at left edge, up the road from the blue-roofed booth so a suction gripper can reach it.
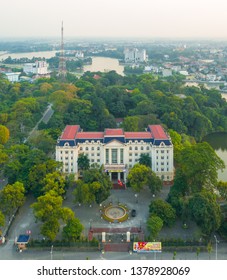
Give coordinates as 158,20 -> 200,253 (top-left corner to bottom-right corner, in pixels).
0,182 -> 25,215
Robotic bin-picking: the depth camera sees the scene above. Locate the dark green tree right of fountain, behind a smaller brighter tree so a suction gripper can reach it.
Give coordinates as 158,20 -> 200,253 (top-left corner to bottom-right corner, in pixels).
149,199 -> 176,227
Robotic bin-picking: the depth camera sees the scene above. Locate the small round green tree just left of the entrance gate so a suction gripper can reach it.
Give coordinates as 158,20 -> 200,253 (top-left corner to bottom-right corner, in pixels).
62,218 -> 84,242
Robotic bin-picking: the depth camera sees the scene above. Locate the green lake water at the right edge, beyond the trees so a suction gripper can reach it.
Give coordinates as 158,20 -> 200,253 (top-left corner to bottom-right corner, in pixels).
203,132 -> 227,182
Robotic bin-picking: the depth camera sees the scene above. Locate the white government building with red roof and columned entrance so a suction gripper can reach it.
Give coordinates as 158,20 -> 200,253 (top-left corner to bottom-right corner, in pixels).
56,125 -> 174,183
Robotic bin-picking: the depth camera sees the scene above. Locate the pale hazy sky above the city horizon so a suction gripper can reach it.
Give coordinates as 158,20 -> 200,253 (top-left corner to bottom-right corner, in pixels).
0,0 -> 227,39
